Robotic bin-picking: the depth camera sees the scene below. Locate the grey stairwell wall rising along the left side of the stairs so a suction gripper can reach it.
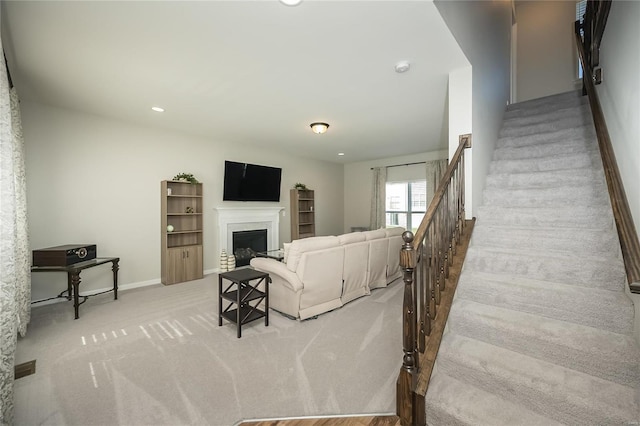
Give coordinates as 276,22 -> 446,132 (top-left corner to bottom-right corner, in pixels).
434,0 -> 512,218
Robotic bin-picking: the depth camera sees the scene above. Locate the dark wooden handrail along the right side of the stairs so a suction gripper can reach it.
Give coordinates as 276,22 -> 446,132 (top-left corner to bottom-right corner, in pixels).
574,0 -> 640,293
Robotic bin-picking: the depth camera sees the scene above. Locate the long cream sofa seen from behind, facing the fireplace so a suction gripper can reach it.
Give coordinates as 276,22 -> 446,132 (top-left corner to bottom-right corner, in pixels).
251,228 -> 404,320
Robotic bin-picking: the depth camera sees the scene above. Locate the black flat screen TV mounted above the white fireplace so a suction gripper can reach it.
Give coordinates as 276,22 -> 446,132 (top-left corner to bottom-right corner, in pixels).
222,161 -> 282,201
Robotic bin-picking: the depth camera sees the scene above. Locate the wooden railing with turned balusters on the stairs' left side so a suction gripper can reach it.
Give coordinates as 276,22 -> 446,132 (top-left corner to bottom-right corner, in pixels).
396,135 -> 471,425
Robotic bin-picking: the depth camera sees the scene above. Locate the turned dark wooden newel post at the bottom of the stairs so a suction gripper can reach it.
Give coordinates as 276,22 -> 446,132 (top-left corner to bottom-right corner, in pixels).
396,231 -> 418,425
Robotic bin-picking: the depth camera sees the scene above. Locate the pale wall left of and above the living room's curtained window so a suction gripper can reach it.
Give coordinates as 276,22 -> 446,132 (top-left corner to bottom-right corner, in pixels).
344,150 -> 447,232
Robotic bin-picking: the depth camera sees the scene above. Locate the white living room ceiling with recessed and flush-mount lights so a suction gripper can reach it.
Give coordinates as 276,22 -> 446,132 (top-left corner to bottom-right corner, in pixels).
2,0 -> 467,162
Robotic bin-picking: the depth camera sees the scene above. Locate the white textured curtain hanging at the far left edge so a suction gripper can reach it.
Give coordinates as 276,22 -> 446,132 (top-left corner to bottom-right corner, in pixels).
0,40 -> 31,425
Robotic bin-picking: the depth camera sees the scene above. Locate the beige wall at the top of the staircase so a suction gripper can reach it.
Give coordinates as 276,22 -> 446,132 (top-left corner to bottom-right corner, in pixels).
516,0 -> 581,102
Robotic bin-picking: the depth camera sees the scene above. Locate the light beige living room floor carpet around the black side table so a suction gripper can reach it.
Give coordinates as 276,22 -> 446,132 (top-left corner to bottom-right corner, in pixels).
15,274 -> 402,425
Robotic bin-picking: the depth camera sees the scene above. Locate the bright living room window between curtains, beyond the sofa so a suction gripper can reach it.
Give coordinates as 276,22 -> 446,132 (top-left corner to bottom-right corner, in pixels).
385,179 -> 427,232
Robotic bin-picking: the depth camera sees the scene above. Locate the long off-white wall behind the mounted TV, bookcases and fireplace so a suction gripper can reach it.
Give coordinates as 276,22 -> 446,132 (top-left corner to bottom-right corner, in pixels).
21,102 -> 344,300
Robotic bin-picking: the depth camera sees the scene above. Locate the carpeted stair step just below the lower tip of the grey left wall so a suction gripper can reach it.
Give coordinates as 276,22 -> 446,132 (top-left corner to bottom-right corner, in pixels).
473,225 -> 620,258
